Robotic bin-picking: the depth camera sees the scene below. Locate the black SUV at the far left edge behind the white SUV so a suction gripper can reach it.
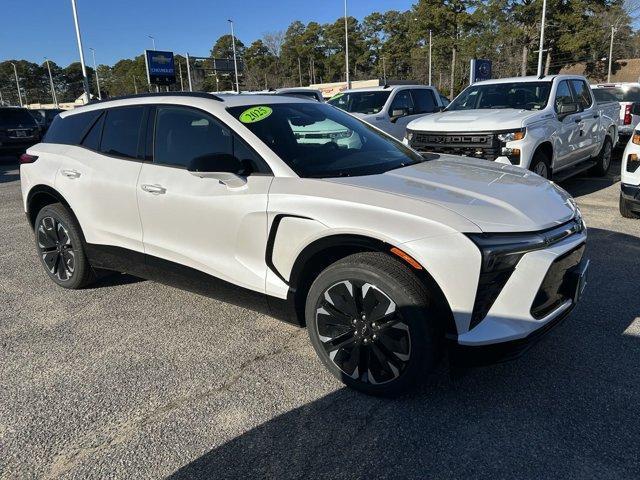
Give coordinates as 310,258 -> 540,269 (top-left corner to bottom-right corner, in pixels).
0,107 -> 40,155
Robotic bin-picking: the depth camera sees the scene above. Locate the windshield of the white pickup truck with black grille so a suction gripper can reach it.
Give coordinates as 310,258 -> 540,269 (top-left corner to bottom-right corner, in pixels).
447,82 -> 551,111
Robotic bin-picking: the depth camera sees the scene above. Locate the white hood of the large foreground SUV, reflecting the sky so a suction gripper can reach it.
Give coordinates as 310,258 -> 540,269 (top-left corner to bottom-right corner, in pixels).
328,155 -> 576,232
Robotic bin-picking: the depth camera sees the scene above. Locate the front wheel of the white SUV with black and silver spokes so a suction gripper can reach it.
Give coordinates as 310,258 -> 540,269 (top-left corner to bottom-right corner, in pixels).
305,252 -> 443,396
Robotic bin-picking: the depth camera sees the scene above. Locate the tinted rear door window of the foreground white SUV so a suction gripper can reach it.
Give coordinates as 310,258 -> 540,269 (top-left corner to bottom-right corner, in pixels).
100,107 -> 144,158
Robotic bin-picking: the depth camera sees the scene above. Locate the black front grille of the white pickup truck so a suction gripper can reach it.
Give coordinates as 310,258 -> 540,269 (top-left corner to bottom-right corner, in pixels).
410,132 -> 502,160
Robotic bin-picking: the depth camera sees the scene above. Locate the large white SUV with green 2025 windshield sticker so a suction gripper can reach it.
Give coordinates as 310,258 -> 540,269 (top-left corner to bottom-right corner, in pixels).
20,93 -> 588,394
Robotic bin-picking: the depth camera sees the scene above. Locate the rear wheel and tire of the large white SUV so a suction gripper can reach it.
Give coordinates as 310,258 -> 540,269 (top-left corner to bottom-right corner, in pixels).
34,203 -> 96,289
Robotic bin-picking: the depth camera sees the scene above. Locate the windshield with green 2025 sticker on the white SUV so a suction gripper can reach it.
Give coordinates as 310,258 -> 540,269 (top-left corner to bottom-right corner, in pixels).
228,102 -> 424,178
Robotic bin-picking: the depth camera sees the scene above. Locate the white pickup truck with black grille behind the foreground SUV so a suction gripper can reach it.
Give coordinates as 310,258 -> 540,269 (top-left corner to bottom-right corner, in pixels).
405,75 -> 620,180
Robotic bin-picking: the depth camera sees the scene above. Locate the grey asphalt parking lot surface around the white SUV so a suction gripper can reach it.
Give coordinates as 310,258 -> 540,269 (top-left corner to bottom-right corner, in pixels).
0,155 -> 640,479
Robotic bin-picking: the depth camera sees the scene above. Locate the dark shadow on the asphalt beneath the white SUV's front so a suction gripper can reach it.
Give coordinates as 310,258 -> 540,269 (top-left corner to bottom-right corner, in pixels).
171,228 -> 640,479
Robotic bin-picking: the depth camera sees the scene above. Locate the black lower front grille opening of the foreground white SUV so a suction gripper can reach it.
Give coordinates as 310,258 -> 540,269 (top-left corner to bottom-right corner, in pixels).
531,244 -> 585,319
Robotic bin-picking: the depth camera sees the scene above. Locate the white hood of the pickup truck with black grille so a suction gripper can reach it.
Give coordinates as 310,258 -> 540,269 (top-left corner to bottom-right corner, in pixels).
407,108 -> 539,133
